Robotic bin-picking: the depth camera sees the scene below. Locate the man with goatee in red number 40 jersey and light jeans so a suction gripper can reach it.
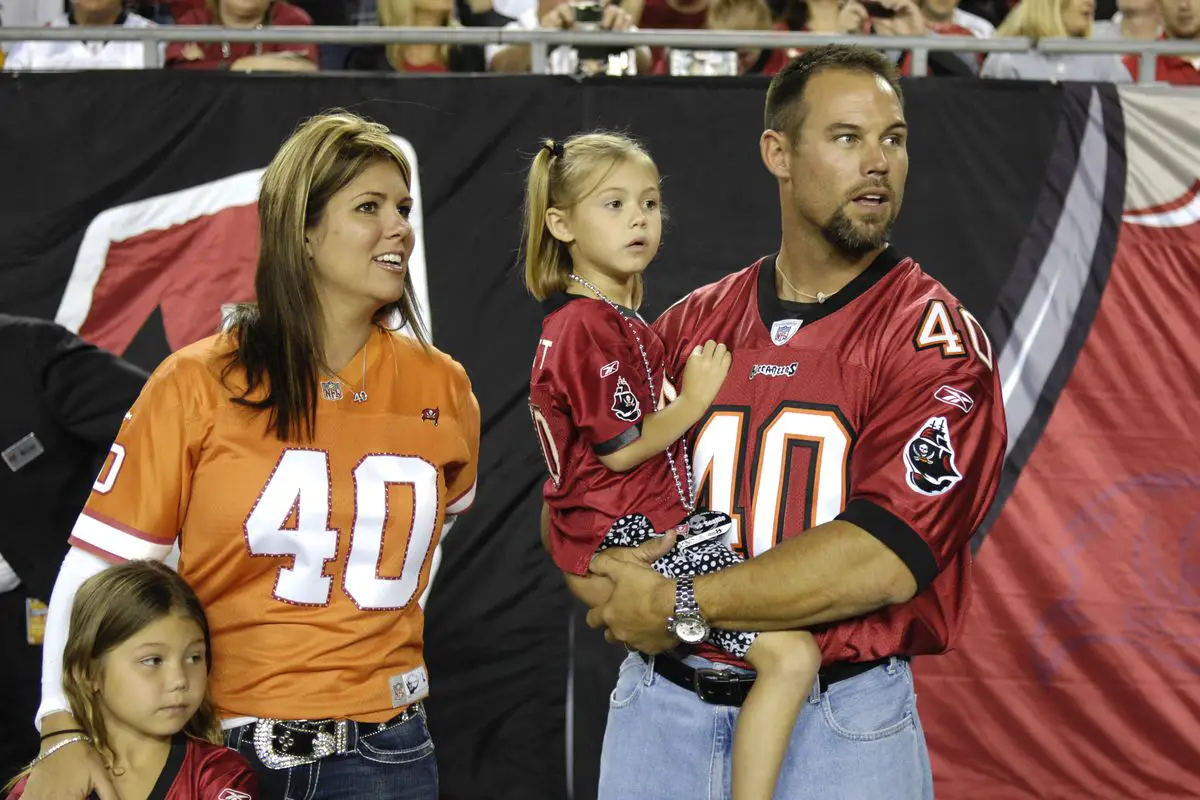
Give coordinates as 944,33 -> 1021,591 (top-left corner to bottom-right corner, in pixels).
556,46 -> 1007,800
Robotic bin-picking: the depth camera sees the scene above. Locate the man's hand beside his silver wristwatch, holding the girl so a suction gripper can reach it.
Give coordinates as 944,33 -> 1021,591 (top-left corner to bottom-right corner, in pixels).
588,547 -> 679,655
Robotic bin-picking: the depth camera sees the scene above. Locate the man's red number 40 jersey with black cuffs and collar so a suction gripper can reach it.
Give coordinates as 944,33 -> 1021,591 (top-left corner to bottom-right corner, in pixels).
655,248 -> 1007,663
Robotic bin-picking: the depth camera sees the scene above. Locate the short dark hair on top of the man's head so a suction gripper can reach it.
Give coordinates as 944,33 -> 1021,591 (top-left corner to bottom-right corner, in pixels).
762,44 -> 904,143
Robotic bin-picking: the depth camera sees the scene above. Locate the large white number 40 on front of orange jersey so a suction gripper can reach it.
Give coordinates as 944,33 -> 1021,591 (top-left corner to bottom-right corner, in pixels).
244,449 -> 440,610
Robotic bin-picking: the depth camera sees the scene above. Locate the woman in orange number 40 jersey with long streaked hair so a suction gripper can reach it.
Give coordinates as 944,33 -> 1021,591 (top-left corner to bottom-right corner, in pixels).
24,113 -> 479,800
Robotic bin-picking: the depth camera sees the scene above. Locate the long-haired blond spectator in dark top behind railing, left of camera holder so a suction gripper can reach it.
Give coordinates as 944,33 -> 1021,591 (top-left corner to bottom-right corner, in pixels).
347,0 -> 484,73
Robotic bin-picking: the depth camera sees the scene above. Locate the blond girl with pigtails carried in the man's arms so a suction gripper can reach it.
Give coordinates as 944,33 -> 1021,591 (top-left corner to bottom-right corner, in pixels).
524,133 -> 821,800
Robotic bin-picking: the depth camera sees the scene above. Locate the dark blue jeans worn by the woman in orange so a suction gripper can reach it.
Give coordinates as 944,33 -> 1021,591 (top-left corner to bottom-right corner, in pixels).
226,710 -> 438,800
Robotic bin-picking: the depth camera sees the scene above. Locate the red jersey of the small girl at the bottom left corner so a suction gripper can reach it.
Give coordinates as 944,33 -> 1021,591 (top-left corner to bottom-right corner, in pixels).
8,734 -> 262,800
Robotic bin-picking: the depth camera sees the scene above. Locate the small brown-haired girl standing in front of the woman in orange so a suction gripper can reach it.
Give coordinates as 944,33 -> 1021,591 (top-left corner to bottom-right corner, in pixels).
8,561 -> 259,800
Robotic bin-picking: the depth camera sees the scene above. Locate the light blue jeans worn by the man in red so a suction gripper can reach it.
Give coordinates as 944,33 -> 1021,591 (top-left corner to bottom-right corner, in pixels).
599,654 -> 934,800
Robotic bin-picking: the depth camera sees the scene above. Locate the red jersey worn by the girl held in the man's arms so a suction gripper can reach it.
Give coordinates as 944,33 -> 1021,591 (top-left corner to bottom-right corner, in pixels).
529,294 -> 688,575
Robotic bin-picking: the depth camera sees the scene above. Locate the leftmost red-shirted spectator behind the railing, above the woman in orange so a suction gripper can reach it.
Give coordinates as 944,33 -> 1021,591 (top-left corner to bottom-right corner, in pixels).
167,0 -> 318,72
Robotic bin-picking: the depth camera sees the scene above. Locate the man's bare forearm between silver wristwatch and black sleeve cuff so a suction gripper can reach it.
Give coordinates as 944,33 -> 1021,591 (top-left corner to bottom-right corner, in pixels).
686,522 -> 917,631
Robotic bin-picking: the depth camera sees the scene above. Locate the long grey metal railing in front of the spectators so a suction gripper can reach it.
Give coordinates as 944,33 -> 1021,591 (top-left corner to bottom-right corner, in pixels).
0,25 -> 1200,83
